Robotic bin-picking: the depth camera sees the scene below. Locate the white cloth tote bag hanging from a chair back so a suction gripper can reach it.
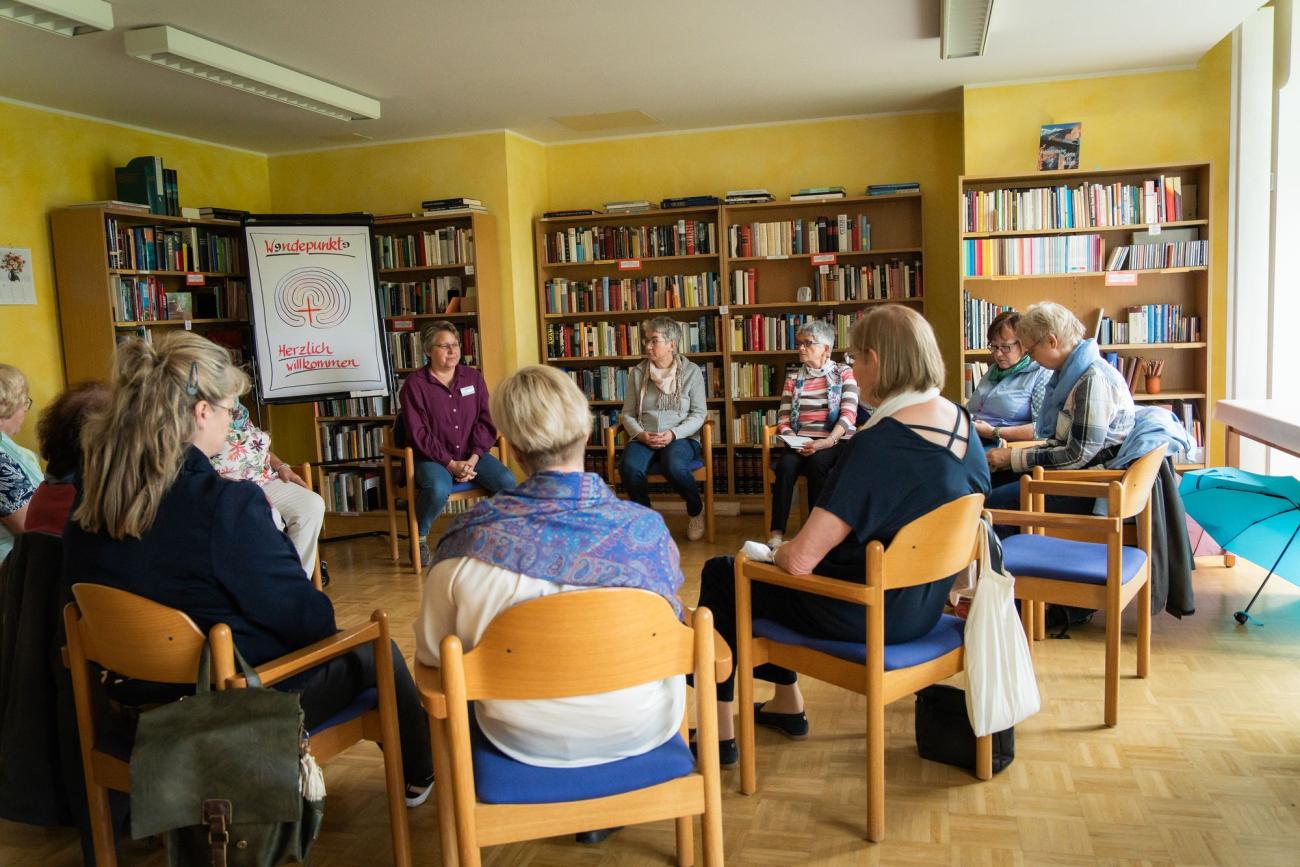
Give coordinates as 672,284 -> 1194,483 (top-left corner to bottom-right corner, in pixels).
966,523 -> 1039,737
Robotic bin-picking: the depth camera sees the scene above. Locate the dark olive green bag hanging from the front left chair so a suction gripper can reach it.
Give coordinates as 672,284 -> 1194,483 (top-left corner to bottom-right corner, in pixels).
131,646 -> 325,867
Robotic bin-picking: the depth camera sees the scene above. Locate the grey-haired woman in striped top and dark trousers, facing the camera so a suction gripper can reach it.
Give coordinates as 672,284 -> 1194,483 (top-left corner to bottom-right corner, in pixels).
767,320 -> 858,547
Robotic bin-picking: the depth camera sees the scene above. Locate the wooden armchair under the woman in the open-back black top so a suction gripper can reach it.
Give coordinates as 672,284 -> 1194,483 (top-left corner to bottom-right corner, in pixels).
736,494 -> 993,842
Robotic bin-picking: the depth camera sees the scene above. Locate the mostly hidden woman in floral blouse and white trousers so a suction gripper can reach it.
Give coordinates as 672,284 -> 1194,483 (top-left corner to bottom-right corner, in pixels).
212,403 -> 325,577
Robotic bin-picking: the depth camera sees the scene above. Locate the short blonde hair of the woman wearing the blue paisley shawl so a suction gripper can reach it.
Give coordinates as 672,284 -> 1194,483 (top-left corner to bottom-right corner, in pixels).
491,364 -> 592,473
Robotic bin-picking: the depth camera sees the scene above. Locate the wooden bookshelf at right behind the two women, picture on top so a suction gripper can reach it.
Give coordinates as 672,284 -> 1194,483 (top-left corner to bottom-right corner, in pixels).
958,162 -> 1213,467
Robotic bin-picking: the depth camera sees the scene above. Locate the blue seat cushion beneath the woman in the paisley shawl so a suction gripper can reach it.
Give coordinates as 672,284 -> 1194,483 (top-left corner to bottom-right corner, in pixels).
469,710 -> 696,803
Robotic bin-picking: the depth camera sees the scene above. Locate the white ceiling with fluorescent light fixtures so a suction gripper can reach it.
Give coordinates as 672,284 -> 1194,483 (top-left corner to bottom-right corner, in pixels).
0,0 -> 1260,153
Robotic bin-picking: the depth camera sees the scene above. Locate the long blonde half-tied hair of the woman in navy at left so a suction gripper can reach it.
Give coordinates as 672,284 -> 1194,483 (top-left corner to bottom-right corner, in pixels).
73,331 -> 248,539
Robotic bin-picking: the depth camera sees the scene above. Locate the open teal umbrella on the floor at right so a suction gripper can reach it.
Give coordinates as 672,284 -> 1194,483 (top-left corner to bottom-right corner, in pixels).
1178,467 -> 1300,623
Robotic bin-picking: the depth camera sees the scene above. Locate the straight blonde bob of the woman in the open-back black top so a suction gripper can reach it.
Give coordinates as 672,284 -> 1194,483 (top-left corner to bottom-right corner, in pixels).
849,304 -> 944,400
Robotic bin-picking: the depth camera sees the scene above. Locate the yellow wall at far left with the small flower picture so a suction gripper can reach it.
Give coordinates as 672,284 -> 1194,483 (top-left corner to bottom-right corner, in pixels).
0,103 -> 270,447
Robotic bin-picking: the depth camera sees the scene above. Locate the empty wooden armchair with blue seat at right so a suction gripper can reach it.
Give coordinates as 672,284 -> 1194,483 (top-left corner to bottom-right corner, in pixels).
991,446 -> 1165,725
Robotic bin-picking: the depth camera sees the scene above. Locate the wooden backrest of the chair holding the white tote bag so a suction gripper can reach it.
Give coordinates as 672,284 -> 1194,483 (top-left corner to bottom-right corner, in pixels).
867,494 -> 984,590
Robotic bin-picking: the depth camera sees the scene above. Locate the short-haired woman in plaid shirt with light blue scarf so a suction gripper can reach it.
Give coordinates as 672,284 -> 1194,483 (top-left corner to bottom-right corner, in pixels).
988,302 -> 1135,512
